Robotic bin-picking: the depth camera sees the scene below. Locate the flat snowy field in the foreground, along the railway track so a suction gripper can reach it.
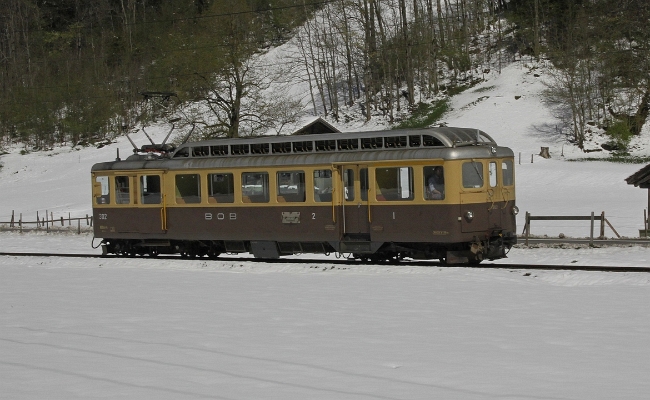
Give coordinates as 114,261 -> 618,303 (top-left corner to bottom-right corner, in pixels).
0,233 -> 650,400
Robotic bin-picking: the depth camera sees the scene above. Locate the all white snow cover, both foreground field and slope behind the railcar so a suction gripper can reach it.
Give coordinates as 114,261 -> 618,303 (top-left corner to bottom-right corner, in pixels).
0,58 -> 650,400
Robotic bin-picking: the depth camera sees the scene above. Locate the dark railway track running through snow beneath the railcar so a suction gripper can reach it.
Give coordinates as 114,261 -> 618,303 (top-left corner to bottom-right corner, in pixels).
0,252 -> 650,273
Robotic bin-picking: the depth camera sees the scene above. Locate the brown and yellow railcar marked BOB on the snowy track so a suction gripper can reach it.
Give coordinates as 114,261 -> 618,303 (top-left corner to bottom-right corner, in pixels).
92,127 -> 518,264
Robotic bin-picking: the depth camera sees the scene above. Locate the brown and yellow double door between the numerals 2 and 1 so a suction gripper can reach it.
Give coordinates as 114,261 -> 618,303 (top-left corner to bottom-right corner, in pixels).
338,165 -> 370,241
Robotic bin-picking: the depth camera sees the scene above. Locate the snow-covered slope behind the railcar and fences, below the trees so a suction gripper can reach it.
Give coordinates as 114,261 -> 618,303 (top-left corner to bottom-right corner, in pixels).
0,62 -> 650,237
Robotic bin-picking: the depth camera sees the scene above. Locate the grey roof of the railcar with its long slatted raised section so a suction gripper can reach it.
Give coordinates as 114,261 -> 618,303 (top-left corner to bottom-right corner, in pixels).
93,127 -> 513,171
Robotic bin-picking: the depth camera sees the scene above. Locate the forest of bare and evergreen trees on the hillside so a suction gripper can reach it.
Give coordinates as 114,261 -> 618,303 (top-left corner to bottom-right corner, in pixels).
0,0 -> 650,149
